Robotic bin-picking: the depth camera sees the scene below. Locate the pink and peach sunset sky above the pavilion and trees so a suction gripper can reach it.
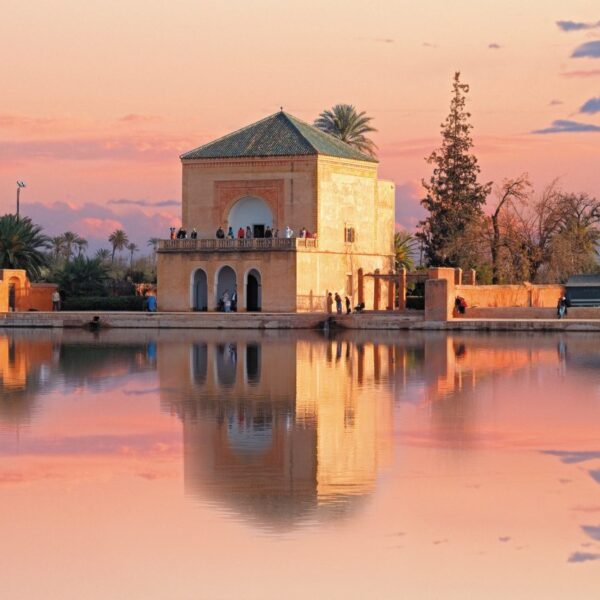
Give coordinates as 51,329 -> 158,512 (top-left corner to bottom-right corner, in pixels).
0,0 -> 600,248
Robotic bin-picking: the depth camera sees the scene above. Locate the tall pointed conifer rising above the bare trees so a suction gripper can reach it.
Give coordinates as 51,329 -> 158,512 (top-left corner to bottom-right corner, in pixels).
417,72 -> 492,267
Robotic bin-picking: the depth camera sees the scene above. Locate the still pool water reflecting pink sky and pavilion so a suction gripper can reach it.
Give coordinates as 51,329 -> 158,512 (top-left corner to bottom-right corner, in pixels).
0,331 -> 600,600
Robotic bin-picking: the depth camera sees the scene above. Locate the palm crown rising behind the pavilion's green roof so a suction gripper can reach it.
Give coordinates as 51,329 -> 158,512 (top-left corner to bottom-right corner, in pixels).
314,104 -> 377,157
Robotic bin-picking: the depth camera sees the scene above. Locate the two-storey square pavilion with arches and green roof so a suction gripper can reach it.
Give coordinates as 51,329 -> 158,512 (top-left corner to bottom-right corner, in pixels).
158,111 -> 394,312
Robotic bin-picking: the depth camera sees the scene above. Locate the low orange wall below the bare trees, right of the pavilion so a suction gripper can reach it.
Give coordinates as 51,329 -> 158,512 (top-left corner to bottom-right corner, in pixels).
455,283 -> 565,308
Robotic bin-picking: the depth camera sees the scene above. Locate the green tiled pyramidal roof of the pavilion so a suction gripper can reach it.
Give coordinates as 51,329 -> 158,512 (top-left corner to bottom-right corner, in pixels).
180,111 -> 377,162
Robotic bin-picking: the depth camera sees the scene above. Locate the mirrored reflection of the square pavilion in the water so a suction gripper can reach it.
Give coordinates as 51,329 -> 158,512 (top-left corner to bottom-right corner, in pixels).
158,332 -> 393,527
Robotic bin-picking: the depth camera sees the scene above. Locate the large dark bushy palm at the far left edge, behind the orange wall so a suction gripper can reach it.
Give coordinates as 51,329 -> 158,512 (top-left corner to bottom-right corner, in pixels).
0,215 -> 50,279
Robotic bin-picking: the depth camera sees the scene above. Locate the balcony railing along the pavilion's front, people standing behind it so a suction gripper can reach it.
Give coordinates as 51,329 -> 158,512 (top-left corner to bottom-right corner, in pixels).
158,238 -> 318,252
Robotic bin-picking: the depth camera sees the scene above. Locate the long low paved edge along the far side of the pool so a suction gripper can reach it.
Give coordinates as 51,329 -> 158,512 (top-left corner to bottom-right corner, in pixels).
0,312 -> 600,332
